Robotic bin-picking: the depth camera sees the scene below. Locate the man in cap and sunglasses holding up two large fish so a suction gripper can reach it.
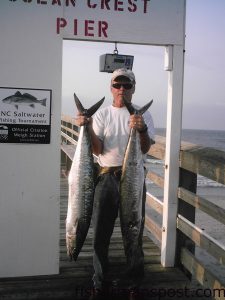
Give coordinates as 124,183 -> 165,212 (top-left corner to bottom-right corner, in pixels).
76,69 -> 154,295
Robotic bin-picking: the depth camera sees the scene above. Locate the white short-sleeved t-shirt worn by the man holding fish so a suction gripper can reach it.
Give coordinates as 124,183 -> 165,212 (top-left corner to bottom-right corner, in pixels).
93,105 -> 155,167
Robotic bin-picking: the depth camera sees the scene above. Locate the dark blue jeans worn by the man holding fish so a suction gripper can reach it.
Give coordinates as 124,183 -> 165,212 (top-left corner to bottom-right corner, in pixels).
92,173 -> 146,289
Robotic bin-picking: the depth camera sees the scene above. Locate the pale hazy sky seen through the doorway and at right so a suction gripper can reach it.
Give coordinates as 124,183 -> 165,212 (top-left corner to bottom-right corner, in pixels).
62,0 -> 225,130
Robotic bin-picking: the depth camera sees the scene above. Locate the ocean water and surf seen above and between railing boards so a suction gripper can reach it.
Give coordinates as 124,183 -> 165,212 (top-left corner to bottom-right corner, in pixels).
146,128 -> 225,246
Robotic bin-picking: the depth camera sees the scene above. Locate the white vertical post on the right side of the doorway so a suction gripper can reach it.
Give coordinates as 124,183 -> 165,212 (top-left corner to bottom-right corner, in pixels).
161,45 -> 184,267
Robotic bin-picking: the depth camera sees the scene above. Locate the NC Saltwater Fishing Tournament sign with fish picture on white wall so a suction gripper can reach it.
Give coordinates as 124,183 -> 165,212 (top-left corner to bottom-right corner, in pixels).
0,88 -> 51,144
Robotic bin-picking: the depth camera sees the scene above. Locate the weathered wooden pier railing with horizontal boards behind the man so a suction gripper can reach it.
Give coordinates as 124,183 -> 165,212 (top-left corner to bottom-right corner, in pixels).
61,116 -> 225,299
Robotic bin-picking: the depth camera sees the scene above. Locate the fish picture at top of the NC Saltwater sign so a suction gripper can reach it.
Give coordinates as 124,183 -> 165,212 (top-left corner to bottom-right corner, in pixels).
2,91 -> 47,109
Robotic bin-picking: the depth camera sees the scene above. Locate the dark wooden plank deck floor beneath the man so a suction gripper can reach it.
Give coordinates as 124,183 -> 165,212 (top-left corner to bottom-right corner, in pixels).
0,178 -> 209,300
